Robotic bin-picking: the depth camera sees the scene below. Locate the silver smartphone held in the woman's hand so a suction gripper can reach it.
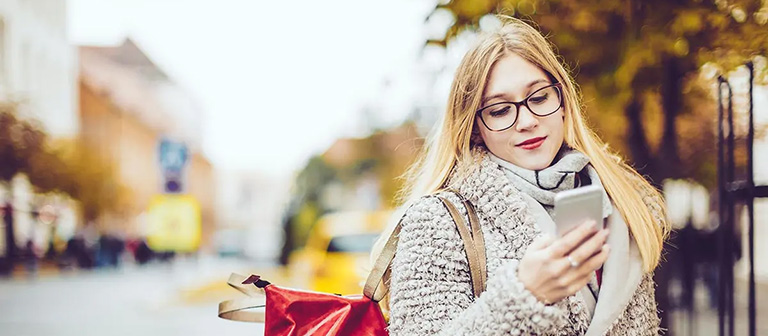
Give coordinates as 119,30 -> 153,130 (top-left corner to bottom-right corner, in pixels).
555,185 -> 603,237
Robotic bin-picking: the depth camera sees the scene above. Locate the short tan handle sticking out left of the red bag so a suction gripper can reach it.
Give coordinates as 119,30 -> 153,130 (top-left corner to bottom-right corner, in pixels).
219,273 -> 267,322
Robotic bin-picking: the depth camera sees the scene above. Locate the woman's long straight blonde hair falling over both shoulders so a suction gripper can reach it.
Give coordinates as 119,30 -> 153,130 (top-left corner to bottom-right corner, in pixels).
372,16 -> 669,280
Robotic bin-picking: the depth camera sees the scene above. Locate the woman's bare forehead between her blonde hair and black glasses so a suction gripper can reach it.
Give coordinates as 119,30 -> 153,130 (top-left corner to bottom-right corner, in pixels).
483,53 -> 549,98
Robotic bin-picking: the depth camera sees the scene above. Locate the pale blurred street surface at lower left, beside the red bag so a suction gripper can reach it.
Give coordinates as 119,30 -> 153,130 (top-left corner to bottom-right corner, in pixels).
0,258 -> 276,336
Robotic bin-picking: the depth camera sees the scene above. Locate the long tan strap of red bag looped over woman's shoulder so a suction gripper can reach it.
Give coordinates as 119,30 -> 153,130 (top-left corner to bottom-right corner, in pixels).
363,189 -> 487,302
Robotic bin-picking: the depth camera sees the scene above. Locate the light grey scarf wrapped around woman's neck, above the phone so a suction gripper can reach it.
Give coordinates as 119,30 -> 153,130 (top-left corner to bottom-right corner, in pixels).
489,147 -> 613,219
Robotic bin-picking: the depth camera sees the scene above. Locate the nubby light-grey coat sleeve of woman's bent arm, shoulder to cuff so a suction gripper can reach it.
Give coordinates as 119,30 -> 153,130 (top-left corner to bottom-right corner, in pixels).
389,197 -> 567,336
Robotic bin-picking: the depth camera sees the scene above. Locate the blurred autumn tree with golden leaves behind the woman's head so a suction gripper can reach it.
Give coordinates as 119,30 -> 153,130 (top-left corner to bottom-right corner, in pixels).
427,0 -> 768,185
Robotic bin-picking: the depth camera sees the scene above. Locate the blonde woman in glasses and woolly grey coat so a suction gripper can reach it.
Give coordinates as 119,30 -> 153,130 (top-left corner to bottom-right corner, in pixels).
374,18 -> 668,336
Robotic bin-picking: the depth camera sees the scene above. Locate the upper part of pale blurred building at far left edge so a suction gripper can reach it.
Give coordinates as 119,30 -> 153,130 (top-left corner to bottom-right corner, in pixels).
0,0 -> 78,137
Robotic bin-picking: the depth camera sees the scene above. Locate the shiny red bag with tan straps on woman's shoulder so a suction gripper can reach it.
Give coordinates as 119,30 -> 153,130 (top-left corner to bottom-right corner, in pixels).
219,193 -> 485,336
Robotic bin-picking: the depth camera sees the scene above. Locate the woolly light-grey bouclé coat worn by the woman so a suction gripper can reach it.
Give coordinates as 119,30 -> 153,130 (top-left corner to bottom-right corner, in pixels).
389,149 -> 661,336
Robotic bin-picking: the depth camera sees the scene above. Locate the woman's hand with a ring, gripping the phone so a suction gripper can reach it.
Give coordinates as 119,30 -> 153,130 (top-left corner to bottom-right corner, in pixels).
517,221 -> 610,304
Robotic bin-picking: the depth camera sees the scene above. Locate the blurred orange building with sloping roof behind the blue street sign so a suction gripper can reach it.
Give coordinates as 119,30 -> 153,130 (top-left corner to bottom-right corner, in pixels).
79,39 -> 216,246
